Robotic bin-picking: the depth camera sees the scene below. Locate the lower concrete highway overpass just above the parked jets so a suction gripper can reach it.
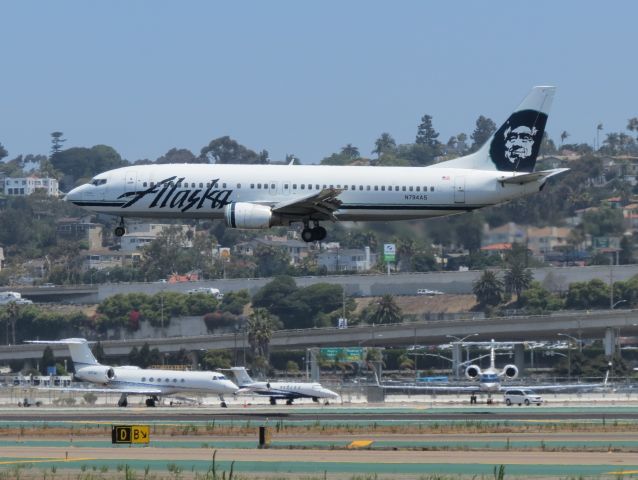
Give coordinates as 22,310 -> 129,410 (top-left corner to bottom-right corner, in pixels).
0,310 -> 638,364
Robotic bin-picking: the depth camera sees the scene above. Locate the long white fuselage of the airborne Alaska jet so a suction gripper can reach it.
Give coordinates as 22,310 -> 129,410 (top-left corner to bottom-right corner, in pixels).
66,164 -> 543,221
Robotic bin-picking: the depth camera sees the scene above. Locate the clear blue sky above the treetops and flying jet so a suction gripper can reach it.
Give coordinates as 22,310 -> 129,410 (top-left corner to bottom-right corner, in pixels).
0,0 -> 638,163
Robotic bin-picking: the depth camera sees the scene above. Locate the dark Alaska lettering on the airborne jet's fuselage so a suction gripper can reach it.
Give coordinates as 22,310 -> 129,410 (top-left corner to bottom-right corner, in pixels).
119,176 -> 233,212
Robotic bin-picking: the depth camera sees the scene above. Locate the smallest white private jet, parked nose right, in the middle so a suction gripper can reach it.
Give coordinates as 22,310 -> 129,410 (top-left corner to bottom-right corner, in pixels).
230,367 -> 339,405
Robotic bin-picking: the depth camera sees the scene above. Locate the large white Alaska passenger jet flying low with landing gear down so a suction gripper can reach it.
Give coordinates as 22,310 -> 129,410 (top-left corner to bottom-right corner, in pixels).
66,87 -> 568,242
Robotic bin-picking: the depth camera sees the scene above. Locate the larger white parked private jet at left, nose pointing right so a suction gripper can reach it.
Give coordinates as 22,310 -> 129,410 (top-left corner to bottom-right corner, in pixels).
27,338 -> 238,407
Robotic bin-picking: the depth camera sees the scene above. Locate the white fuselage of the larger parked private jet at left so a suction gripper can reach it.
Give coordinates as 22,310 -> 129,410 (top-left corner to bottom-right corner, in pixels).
76,365 -> 237,395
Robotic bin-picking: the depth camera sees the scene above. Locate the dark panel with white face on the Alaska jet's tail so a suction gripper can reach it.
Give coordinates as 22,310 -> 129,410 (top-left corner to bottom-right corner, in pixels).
490,110 -> 547,172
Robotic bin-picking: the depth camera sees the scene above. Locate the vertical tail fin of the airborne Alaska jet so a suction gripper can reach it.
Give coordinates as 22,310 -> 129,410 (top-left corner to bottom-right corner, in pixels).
431,87 -> 556,173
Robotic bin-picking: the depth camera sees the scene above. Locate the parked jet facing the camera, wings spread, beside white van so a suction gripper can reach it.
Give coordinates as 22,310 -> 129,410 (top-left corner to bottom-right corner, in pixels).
375,340 -> 609,404
